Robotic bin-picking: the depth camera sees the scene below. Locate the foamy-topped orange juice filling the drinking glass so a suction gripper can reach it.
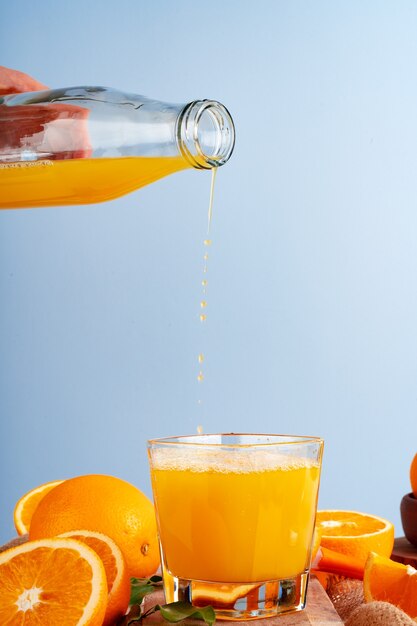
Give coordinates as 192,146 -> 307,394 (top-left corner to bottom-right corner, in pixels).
151,449 -> 320,583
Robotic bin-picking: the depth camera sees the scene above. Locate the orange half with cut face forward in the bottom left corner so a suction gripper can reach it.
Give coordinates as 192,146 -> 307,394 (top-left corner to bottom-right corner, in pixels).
0,538 -> 107,626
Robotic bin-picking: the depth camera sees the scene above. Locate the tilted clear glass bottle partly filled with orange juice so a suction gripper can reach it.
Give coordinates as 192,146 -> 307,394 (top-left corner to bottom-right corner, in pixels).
0,87 -> 235,208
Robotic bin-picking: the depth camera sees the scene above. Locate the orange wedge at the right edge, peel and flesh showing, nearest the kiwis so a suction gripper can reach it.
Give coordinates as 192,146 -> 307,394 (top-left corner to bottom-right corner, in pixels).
363,552 -> 417,620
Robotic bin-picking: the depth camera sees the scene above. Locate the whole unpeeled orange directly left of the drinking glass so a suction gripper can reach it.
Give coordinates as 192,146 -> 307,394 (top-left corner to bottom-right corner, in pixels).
29,474 -> 159,578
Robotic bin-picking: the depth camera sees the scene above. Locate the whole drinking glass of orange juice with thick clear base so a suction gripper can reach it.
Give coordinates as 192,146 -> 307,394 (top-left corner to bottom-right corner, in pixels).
148,434 -> 323,620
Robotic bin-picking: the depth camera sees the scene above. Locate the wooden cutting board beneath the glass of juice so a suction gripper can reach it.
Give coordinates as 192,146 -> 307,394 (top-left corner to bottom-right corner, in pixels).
142,577 -> 343,626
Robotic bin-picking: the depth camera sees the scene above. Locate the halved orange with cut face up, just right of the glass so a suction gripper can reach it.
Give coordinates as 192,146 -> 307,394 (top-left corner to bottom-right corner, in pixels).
316,510 -> 394,566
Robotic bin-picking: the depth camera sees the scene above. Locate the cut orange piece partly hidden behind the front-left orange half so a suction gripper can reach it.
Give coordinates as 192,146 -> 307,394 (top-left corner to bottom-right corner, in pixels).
59,530 -> 130,626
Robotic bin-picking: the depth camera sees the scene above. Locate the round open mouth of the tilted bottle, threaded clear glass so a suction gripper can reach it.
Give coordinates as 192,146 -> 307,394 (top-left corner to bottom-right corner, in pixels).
177,100 -> 235,169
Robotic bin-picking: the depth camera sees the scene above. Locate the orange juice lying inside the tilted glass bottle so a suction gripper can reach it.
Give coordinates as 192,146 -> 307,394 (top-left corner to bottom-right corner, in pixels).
0,156 -> 189,209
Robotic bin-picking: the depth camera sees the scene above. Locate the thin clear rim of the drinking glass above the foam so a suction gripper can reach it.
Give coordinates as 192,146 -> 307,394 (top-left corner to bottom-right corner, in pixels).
147,432 -> 324,448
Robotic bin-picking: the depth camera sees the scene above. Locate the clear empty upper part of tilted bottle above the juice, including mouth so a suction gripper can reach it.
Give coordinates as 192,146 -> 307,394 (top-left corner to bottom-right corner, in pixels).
0,87 -> 235,169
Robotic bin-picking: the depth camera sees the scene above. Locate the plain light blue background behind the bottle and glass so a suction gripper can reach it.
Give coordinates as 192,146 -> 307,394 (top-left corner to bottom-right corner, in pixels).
0,0 -> 417,543
